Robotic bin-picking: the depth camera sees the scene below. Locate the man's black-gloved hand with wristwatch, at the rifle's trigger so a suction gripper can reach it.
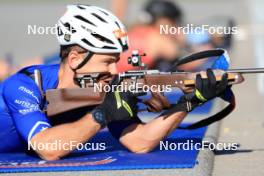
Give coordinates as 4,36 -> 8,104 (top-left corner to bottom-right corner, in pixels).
92,77 -> 138,127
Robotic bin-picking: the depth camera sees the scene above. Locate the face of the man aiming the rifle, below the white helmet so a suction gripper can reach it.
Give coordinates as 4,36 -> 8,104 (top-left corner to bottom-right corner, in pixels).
77,53 -> 120,84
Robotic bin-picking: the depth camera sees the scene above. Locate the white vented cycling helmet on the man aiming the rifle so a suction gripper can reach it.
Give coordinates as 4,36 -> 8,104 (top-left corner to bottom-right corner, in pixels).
57,5 -> 128,53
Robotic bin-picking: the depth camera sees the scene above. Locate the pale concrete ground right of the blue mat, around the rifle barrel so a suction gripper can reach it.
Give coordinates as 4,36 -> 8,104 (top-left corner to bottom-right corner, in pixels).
213,39 -> 264,176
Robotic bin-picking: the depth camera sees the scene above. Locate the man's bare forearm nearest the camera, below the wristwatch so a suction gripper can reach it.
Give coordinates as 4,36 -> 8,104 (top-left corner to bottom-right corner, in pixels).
30,114 -> 101,160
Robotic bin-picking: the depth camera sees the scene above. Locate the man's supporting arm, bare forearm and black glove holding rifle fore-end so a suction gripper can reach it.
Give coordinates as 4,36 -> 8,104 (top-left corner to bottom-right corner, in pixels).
119,70 -> 228,153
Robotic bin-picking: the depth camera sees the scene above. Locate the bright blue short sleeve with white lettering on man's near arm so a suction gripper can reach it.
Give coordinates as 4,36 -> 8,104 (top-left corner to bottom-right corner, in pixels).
3,74 -> 51,142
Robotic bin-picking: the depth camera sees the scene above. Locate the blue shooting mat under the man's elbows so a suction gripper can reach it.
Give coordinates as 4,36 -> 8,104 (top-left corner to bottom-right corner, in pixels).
0,125 -> 206,173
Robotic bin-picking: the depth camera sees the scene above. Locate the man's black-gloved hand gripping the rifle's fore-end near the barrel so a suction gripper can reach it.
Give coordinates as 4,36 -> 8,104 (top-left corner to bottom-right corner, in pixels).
163,69 -> 228,115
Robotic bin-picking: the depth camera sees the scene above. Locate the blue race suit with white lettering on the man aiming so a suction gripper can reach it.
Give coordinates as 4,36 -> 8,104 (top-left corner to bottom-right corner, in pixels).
0,65 -> 140,152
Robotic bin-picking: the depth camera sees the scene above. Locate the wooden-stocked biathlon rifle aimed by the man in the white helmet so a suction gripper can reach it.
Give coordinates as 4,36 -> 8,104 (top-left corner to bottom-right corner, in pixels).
46,49 -> 264,128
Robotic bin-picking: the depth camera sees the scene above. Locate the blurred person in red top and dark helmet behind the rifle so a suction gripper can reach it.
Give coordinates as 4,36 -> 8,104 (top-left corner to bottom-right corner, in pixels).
118,0 -> 185,72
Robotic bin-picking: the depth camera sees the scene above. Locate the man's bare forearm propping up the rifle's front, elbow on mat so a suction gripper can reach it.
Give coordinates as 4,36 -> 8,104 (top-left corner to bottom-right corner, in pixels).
120,112 -> 187,153
